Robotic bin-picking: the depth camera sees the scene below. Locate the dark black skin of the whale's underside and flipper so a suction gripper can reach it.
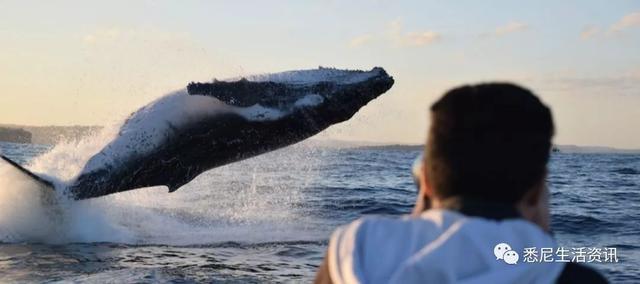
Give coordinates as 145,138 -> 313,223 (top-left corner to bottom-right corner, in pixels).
66,67 -> 394,200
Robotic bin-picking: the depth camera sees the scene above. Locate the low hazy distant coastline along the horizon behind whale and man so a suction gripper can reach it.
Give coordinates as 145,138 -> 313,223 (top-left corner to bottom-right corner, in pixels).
0,124 -> 640,154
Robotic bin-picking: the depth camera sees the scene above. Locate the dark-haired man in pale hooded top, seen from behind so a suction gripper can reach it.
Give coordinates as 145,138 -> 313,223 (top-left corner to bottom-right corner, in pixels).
316,83 -> 606,283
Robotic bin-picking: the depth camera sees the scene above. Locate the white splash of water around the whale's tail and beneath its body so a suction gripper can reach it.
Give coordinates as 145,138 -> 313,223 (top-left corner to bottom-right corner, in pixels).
0,117 -> 321,245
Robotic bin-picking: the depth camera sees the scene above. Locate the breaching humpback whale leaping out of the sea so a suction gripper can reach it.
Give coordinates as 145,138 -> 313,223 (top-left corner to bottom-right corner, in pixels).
2,67 -> 394,200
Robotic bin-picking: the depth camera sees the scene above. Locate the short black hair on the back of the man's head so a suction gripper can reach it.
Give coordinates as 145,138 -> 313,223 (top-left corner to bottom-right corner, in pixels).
424,83 -> 554,203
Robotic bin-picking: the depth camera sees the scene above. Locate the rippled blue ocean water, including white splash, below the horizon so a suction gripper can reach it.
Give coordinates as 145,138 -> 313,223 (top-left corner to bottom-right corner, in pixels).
0,143 -> 640,283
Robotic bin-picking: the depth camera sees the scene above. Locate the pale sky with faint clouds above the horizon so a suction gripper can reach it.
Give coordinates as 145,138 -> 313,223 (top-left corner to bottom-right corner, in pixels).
0,0 -> 640,148
